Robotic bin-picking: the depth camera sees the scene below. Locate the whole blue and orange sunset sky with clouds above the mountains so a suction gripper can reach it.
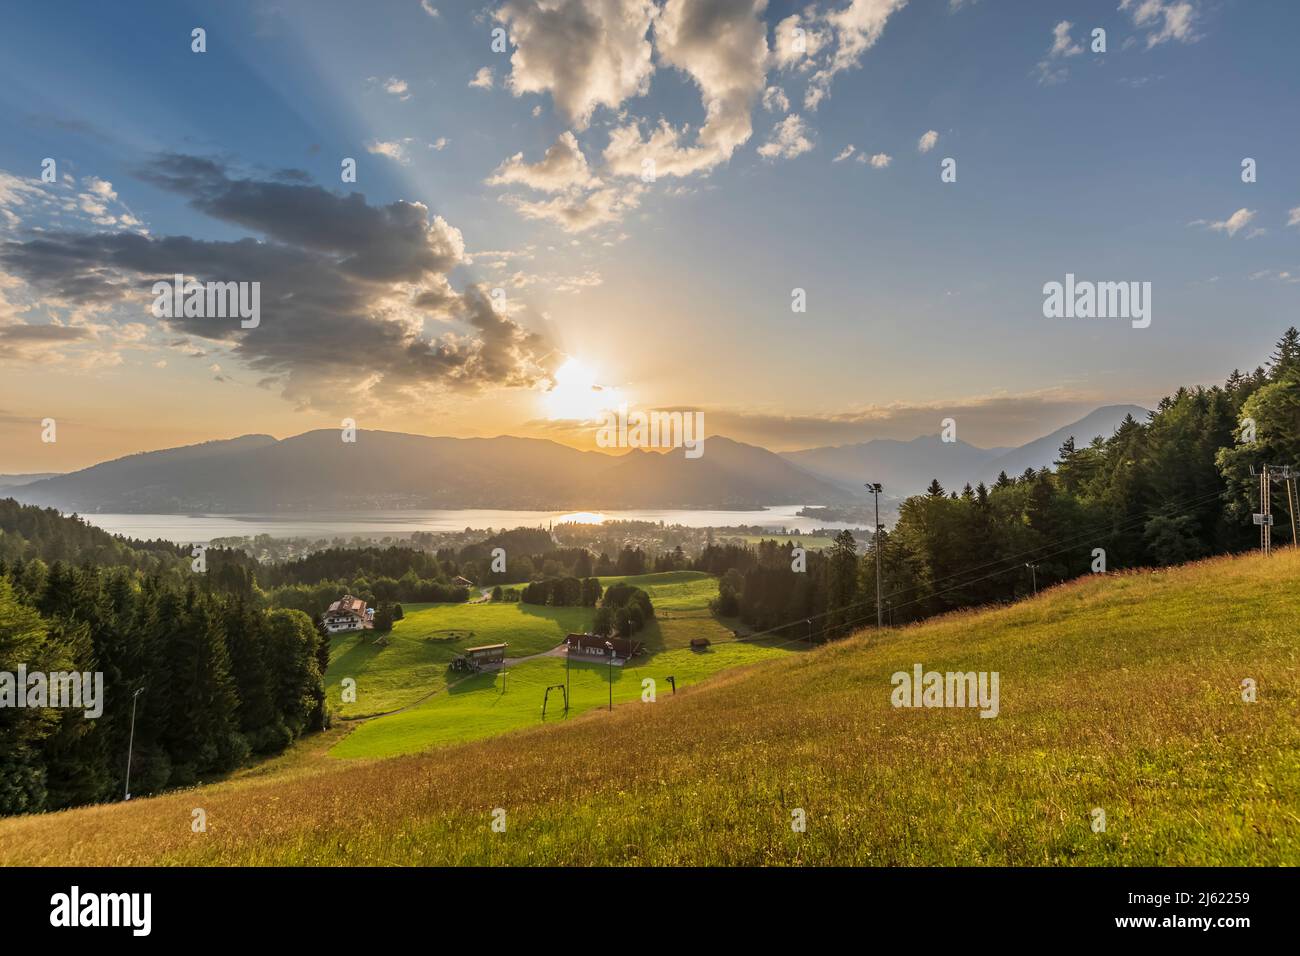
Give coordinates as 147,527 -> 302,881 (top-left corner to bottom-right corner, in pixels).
0,0 -> 1300,473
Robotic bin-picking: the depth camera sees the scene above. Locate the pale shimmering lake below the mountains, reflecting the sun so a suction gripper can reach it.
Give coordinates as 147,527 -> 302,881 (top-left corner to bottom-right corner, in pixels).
82,505 -> 854,544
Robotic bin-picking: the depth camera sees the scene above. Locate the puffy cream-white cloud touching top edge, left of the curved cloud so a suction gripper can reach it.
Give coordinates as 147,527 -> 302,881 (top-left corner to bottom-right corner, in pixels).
493,0 -> 655,130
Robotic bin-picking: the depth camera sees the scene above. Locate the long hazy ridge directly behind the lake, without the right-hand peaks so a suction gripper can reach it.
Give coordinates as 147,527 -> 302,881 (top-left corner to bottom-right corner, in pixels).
8,429 -> 849,514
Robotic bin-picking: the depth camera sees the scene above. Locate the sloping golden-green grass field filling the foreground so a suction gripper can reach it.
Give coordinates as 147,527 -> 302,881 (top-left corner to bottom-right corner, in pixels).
0,551 -> 1300,865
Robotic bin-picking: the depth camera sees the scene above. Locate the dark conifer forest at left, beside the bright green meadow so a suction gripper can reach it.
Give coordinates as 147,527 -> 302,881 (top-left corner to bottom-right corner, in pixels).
0,558 -> 329,813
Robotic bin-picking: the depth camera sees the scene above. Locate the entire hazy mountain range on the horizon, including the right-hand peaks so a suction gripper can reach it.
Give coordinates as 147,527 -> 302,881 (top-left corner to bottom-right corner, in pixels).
0,406 -> 1145,514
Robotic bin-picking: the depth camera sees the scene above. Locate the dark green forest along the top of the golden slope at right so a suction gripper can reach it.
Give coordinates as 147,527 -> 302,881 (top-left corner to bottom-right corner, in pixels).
712,328 -> 1300,637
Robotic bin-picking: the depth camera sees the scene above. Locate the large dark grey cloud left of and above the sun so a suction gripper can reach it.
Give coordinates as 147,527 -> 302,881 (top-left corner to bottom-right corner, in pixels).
0,153 -> 553,406
